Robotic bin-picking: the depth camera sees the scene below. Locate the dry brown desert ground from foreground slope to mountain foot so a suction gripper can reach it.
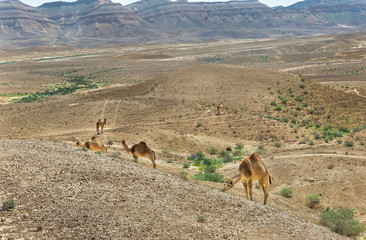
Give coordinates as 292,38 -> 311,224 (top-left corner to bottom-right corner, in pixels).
0,33 -> 366,239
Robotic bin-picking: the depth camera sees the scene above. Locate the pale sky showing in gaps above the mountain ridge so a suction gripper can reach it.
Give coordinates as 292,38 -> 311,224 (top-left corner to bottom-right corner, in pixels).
20,0 -> 300,7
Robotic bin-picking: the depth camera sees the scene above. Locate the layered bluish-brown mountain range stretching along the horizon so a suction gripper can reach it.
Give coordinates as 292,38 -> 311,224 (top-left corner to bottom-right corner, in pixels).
0,0 -> 366,47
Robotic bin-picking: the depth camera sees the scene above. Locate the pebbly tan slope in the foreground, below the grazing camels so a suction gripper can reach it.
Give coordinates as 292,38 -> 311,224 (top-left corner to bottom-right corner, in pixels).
0,139 -> 345,240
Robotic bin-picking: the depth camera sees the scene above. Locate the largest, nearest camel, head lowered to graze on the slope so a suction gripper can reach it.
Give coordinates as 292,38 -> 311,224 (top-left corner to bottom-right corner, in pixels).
223,153 -> 272,205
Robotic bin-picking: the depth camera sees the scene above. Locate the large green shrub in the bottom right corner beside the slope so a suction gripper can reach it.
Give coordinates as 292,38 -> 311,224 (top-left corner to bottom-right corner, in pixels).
319,207 -> 366,237
